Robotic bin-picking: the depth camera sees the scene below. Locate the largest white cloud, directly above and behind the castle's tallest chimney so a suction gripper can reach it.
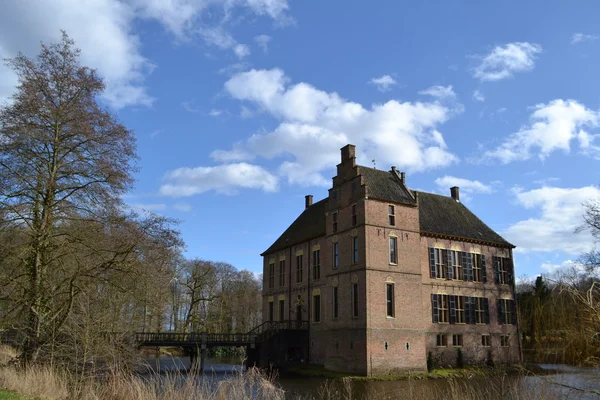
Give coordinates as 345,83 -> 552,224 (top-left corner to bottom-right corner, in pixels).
212,69 -> 458,185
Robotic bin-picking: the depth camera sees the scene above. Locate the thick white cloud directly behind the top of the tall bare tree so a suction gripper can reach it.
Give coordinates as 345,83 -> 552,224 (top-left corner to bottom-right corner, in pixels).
0,0 -> 154,109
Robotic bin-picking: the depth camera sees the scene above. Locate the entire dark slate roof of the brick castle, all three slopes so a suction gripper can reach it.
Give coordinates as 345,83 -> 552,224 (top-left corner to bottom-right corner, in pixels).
263,166 -> 515,255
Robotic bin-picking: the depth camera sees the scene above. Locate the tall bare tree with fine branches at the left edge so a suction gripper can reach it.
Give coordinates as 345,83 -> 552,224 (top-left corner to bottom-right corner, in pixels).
0,32 -> 139,363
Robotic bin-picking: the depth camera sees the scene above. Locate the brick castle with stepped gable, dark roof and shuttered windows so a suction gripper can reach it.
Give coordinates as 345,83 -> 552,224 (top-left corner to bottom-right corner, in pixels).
262,145 -> 521,375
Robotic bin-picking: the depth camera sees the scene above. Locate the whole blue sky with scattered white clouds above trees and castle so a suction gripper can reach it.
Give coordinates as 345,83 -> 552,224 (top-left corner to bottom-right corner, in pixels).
0,0 -> 600,276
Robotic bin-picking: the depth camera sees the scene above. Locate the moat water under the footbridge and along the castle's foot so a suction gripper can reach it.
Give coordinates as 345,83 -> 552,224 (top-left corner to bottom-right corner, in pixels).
146,356 -> 600,400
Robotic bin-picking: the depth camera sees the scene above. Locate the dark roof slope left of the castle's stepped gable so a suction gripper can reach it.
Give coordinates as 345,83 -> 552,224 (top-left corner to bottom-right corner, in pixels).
261,198 -> 328,255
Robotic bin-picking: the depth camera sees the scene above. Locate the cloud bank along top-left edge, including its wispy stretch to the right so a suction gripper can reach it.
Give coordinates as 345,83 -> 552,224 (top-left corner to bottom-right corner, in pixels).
0,0 -> 290,109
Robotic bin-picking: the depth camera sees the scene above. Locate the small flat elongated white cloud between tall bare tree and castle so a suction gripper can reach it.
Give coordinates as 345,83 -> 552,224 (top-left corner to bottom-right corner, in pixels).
160,163 -> 277,197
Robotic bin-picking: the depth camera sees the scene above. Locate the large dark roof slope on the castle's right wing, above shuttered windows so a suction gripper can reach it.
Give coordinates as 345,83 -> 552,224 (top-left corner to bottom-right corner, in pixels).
418,192 -> 514,247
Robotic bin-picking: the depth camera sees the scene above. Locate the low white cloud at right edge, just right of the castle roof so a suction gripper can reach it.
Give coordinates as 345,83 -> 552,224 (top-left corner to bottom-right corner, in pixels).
503,186 -> 600,254
